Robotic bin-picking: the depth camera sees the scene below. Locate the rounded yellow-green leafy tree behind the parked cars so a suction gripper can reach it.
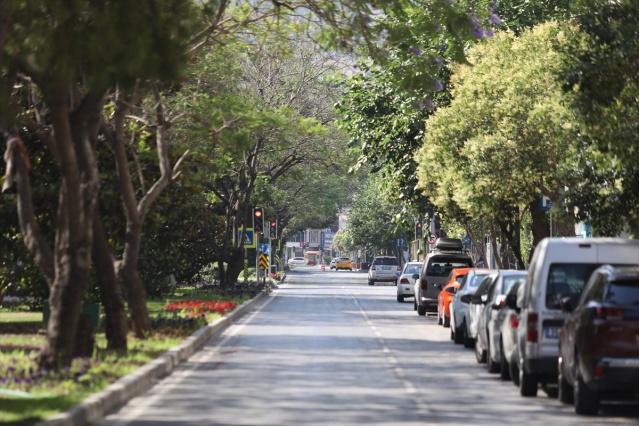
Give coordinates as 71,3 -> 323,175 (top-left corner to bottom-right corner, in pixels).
418,24 -> 578,265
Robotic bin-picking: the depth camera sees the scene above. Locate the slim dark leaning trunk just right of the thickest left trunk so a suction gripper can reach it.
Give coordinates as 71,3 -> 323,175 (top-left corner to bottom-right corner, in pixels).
91,211 -> 127,354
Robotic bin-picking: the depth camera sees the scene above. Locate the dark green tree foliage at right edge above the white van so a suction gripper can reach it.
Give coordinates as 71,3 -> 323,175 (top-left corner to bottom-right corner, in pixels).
562,0 -> 639,236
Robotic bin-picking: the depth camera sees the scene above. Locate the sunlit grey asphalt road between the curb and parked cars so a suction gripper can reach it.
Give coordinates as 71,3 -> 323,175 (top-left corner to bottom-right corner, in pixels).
99,267 -> 639,426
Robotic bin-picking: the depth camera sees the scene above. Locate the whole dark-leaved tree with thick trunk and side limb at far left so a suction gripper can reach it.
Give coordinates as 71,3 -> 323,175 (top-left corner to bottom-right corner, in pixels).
0,1 -> 198,367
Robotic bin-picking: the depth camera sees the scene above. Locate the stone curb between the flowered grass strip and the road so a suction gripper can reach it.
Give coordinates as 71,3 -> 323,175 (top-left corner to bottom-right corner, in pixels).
38,291 -> 268,426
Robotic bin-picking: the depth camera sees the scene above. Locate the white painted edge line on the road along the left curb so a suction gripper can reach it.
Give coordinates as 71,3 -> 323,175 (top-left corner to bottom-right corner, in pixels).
104,293 -> 275,426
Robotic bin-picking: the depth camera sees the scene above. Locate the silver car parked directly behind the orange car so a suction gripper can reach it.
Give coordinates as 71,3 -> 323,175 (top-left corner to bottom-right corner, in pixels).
450,269 -> 492,348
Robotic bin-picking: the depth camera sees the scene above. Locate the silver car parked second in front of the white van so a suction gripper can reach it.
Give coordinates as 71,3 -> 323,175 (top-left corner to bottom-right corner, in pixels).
475,269 -> 528,373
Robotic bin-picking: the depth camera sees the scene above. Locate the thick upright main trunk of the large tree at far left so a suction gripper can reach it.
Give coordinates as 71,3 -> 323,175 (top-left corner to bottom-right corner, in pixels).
38,88 -> 102,368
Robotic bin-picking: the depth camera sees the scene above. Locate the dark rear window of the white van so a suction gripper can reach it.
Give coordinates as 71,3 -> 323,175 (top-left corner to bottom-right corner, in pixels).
546,263 -> 599,309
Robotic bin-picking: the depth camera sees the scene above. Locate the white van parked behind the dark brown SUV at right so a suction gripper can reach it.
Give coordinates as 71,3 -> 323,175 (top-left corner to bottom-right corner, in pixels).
517,238 -> 639,396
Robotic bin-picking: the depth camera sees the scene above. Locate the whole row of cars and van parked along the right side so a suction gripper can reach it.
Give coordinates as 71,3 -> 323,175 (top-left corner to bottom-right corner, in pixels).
397,238 -> 639,414
